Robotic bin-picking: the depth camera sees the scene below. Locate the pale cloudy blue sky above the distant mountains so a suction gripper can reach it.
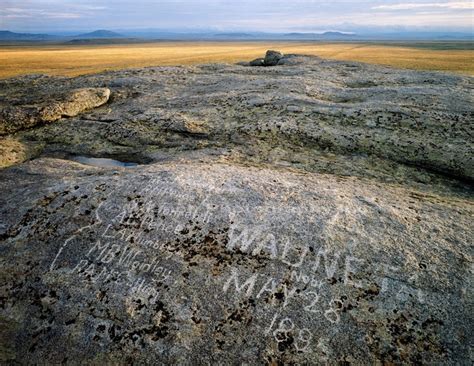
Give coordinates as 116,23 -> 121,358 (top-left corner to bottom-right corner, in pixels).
0,0 -> 474,32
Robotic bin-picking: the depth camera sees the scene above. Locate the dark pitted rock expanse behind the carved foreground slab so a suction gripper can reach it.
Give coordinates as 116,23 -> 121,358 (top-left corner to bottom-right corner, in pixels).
0,56 -> 474,181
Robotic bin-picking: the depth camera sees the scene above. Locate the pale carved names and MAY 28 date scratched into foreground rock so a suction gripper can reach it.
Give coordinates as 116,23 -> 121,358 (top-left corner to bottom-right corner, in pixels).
44,180 -> 424,352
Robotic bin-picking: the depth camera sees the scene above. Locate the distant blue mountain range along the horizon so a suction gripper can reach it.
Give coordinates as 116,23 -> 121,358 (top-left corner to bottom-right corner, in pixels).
0,29 -> 474,44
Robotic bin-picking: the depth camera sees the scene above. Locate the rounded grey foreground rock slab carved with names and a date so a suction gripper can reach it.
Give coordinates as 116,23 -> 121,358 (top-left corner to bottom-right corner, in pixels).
0,159 -> 474,364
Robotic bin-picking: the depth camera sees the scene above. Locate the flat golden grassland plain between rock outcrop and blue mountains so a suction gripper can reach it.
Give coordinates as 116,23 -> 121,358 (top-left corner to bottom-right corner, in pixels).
0,41 -> 474,78
